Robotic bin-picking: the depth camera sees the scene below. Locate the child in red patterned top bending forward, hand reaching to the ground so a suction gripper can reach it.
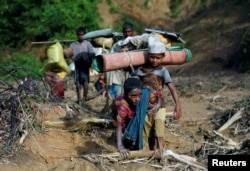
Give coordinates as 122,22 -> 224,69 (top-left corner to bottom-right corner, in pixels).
111,78 -> 142,158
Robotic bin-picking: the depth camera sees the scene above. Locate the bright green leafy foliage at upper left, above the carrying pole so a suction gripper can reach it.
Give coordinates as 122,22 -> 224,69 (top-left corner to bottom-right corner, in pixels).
0,0 -> 101,47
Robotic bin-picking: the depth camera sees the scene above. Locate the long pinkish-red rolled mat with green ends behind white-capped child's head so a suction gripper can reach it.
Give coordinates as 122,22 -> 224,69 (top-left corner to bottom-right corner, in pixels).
92,46 -> 192,72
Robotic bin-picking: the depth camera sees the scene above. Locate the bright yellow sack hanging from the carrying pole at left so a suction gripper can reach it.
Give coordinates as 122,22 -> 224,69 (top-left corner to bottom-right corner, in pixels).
43,41 -> 70,73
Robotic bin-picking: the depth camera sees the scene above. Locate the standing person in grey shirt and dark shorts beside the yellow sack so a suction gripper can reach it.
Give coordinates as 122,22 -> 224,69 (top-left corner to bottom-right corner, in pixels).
70,27 -> 95,106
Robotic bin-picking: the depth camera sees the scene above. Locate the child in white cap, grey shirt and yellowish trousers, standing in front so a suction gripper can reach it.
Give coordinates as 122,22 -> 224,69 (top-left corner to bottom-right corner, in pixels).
132,42 -> 182,150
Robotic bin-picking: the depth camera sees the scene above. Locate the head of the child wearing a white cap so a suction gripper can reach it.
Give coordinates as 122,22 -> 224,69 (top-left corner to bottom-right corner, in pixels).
148,42 -> 166,67
